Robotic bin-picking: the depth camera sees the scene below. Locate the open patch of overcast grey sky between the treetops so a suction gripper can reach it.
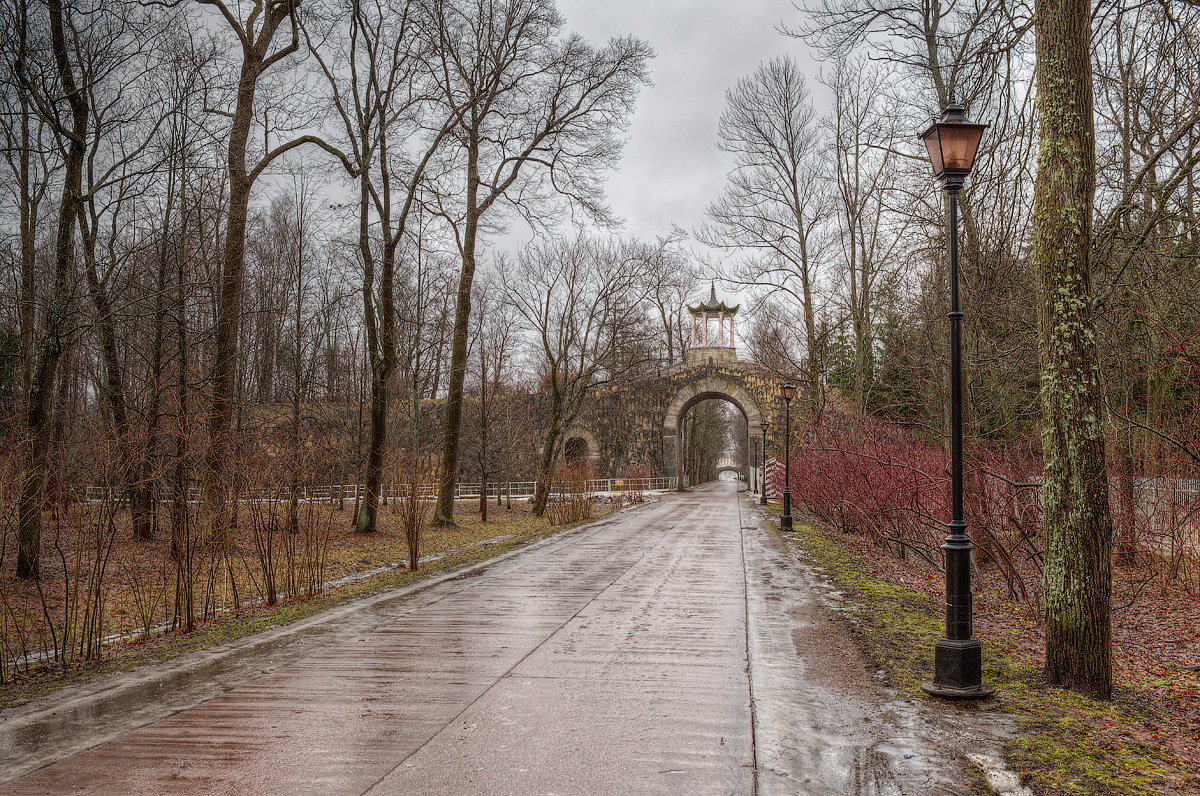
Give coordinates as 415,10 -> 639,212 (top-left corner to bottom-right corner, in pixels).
558,0 -> 817,238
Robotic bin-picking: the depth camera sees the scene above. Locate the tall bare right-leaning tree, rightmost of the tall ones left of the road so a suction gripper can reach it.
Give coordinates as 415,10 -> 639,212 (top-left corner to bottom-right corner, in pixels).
432,0 -> 650,525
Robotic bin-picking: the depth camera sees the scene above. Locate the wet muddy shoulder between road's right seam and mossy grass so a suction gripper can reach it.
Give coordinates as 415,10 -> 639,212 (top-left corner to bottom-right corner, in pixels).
743,507 -> 1003,796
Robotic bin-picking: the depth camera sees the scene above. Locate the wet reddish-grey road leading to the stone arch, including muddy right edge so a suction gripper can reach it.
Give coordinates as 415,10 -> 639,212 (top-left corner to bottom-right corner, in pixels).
0,484 -> 1003,794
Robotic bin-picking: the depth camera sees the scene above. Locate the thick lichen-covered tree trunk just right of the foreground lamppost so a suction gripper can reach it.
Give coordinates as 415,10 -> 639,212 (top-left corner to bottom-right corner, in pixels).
1033,0 -> 1112,699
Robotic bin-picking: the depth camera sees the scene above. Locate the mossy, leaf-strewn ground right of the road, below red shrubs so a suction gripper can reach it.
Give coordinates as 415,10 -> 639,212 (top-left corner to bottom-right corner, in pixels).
790,504 -> 1200,795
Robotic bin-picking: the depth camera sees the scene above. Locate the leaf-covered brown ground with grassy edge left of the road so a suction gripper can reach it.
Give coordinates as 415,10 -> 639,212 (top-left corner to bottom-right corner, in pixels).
0,501 -> 633,710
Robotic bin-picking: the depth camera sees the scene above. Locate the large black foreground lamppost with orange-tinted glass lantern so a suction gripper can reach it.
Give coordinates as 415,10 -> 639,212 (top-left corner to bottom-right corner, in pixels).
920,96 -> 995,699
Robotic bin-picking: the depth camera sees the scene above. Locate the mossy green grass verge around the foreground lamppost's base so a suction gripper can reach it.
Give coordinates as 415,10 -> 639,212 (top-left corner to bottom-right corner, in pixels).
772,513 -> 1185,796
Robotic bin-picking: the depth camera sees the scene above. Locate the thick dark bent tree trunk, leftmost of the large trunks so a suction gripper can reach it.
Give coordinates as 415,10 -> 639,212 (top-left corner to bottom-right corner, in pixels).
17,0 -> 88,579
